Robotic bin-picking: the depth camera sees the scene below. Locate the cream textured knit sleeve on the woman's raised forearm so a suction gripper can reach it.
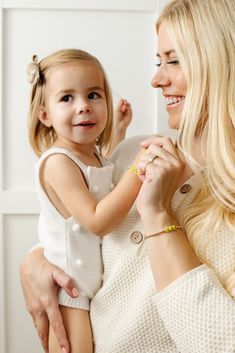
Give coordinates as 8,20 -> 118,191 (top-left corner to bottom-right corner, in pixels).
155,265 -> 235,353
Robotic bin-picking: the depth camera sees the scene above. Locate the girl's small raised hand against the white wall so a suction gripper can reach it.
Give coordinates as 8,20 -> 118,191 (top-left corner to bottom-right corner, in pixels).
113,99 -> 132,138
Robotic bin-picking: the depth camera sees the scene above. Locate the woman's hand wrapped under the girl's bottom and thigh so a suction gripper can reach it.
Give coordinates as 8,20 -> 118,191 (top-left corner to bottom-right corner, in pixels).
20,248 -> 78,353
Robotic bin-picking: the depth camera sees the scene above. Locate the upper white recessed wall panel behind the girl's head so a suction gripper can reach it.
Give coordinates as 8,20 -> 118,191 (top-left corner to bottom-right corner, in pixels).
3,10 -> 156,190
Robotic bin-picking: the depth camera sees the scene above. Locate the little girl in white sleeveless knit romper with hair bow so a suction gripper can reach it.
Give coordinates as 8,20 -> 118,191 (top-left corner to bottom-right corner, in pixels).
28,49 -> 141,353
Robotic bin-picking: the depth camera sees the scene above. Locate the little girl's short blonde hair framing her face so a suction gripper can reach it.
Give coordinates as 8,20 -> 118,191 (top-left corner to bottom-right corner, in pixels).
28,49 -> 113,156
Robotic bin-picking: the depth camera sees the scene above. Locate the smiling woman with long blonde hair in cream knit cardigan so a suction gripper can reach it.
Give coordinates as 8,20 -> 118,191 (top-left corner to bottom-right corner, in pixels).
21,0 -> 235,353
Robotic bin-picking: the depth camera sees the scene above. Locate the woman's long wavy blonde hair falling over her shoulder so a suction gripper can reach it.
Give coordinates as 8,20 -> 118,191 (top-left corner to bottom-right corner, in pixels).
156,0 -> 235,295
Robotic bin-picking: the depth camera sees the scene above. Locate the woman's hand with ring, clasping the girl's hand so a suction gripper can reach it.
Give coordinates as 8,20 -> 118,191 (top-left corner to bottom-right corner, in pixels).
137,136 -> 184,217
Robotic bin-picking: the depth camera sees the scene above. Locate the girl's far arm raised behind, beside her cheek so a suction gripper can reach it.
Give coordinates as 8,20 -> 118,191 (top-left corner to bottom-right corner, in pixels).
102,99 -> 132,158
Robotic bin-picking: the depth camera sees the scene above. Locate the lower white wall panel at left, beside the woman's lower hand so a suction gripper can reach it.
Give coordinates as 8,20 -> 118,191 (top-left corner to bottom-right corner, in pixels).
1,215 -> 42,353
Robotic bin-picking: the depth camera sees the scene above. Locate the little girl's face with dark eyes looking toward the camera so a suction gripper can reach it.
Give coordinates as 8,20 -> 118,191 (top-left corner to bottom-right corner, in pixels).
40,62 -> 108,145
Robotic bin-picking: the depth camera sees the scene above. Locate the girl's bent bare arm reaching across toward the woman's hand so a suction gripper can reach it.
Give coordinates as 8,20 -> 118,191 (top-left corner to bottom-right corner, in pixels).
41,150 -> 143,235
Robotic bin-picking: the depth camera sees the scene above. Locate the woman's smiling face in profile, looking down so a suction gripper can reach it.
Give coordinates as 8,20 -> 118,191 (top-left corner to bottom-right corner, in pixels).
152,23 -> 187,129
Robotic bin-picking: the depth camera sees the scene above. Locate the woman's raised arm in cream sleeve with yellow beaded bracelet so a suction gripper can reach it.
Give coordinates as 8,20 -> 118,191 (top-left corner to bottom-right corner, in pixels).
137,134 -> 235,353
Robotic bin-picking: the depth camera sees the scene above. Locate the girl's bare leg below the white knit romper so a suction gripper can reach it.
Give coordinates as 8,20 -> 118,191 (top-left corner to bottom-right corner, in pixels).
49,306 -> 93,353
